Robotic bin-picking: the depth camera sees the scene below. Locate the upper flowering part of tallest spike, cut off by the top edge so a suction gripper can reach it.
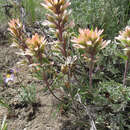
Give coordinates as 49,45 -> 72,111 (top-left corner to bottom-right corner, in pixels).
41,0 -> 70,31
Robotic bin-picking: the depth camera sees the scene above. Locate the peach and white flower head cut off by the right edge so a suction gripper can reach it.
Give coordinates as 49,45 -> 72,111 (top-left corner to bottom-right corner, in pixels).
116,26 -> 130,58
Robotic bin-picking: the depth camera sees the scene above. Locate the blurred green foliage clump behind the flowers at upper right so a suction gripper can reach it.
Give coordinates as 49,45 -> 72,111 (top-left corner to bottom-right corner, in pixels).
71,0 -> 130,38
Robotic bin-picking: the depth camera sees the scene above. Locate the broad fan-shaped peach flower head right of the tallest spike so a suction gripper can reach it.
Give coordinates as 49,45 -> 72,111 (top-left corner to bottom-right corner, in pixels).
72,28 -> 110,56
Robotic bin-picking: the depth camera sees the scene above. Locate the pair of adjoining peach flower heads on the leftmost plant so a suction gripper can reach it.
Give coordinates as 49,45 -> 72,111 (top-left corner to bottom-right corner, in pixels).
8,19 -> 46,64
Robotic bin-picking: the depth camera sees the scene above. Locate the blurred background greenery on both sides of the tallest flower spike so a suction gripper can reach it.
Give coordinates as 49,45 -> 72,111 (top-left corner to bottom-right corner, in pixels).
0,0 -> 130,38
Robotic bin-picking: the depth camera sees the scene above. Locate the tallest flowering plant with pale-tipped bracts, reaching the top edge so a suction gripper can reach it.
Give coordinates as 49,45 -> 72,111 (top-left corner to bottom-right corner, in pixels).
41,0 -> 87,105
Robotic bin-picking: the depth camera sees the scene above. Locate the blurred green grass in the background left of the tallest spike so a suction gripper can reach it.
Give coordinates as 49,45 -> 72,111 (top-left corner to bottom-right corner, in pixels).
0,0 -> 46,24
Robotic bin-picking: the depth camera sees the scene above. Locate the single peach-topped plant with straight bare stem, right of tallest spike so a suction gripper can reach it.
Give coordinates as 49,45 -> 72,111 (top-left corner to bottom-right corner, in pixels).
72,28 -> 110,87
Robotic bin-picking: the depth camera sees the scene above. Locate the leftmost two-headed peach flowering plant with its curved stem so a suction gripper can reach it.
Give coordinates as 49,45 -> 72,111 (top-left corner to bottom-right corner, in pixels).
8,19 -> 60,100
